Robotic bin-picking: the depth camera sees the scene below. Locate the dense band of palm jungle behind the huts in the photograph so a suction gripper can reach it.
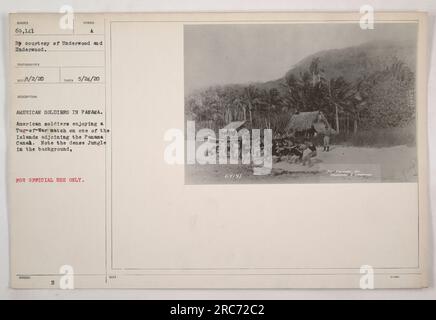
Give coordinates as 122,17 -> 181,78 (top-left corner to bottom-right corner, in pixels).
185,58 -> 415,138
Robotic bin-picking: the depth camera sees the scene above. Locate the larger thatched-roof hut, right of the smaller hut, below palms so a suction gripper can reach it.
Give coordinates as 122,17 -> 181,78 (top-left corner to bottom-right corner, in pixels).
286,111 -> 335,134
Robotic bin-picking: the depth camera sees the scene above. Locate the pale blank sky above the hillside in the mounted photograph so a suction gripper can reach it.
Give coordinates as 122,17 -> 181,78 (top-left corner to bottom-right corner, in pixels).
184,23 -> 417,94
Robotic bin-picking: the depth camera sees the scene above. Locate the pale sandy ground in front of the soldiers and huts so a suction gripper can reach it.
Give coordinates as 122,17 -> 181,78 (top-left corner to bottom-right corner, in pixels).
185,145 -> 417,184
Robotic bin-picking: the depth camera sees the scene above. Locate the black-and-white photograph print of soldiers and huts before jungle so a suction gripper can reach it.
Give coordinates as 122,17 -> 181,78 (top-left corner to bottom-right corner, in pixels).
184,22 -> 418,184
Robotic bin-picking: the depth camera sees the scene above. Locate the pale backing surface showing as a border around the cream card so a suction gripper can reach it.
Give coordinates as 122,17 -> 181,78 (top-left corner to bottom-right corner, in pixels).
0,0 -> 436,299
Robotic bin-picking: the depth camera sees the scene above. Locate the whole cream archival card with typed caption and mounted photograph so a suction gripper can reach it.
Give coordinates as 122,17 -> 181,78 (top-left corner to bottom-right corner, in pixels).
8,12 -> 428,289
